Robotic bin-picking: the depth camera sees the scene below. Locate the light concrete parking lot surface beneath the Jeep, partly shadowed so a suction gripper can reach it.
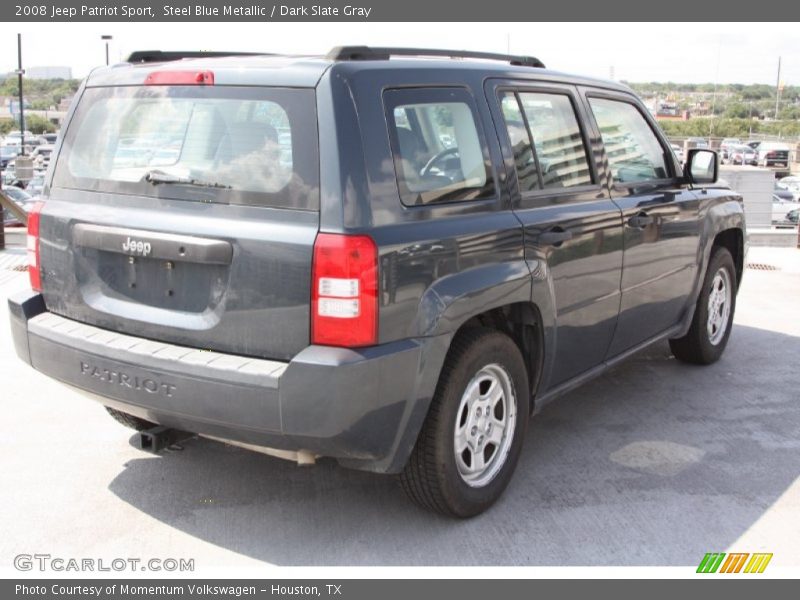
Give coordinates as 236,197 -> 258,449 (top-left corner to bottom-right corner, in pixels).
0,248 -> 800,571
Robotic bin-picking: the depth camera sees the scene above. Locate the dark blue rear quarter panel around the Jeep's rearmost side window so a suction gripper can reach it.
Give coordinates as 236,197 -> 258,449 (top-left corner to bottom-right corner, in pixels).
318,61 -> 531,343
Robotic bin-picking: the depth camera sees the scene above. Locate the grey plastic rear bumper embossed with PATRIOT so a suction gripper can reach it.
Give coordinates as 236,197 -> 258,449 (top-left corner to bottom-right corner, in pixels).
9,293 -> 449,473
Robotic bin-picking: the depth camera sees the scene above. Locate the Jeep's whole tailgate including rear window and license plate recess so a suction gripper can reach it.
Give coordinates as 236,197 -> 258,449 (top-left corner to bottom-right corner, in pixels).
39,81 -> 319,359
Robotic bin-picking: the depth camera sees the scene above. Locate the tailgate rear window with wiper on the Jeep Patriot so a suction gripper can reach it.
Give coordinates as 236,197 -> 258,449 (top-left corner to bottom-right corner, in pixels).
53,86 -> 319,210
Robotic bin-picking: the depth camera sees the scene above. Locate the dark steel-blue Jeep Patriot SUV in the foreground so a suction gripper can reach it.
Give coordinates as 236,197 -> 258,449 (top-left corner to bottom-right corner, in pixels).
10,47 -> 746,517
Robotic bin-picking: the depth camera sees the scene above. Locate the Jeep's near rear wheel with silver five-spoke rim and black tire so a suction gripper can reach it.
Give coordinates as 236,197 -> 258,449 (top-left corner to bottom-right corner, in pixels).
400,328 -> 530,518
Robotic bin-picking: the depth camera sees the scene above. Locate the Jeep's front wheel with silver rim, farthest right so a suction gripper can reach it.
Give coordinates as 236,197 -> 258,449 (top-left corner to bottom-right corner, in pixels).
669,246 -> 737,365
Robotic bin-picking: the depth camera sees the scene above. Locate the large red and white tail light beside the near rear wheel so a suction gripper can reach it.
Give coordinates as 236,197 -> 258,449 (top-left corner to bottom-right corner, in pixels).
311,233 -> 378,348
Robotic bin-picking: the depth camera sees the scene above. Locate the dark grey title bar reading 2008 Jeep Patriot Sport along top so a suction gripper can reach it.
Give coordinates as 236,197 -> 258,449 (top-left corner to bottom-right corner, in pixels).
6,0 -> 800,21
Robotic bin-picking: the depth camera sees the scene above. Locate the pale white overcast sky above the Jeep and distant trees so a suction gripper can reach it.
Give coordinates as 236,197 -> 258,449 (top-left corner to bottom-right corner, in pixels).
0,23 -> 800,85
